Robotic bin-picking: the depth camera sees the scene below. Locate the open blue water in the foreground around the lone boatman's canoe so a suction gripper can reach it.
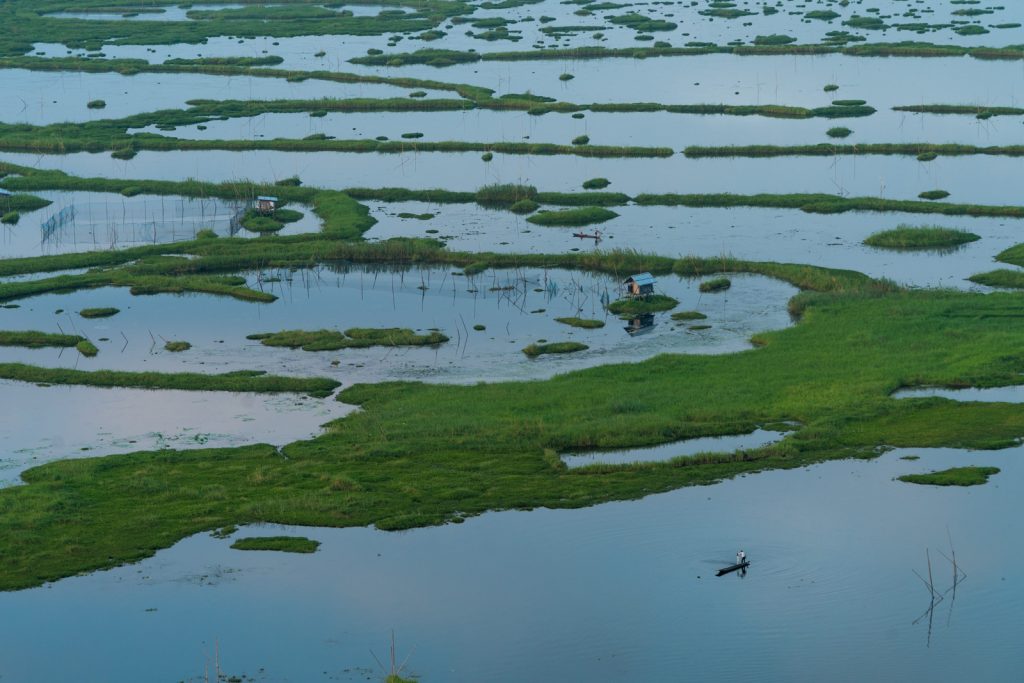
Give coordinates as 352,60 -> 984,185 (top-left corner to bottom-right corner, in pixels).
0,449 -> 1024,683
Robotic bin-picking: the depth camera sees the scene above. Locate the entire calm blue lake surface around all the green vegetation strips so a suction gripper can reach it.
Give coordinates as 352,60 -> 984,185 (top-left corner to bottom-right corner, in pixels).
0,0 -> 1024,683
